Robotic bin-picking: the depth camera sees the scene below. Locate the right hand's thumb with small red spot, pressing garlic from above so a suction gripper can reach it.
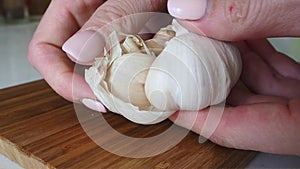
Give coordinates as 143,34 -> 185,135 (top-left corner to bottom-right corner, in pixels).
168,0 -> 300,41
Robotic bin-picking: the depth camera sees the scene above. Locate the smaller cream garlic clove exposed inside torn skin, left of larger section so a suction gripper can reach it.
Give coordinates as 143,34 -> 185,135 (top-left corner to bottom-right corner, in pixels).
106,53 -> 155,109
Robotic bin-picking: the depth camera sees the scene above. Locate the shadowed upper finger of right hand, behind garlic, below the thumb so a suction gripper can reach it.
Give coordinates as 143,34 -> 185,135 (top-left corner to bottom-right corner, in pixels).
238,42 -> 300,98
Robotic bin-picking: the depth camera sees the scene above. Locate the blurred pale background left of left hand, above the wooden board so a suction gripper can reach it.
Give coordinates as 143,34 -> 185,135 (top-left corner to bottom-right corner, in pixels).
0,0 -> 51,89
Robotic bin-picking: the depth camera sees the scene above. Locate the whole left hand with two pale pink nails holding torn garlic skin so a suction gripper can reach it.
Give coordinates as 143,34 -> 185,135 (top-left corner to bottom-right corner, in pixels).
28,0 -> 167,112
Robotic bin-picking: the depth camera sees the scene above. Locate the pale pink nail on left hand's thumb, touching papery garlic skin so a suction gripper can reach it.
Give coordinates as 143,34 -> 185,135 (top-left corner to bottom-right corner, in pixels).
62,31 -> 104,64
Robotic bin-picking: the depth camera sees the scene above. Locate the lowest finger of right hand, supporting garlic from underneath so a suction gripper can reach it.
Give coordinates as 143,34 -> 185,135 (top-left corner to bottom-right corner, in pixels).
170,99 -> 300,155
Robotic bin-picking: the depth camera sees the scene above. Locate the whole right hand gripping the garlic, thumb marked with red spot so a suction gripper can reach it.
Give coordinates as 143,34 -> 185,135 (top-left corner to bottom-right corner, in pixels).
168,0 -> 300,155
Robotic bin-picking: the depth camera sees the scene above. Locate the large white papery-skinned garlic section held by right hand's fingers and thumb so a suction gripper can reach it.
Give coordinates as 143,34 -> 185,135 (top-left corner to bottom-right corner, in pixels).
145,33 -> 242,111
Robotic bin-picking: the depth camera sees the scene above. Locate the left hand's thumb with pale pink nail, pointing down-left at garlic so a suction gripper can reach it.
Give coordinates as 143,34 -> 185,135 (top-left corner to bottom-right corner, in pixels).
63,0 -> 167,65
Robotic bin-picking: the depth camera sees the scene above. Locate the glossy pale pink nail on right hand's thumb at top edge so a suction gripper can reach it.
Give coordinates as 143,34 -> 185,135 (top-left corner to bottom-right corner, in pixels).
168,0 -> 207,20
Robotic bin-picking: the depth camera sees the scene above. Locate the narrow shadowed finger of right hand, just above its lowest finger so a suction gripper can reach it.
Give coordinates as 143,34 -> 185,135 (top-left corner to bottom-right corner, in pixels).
226,82 -> 288,106
